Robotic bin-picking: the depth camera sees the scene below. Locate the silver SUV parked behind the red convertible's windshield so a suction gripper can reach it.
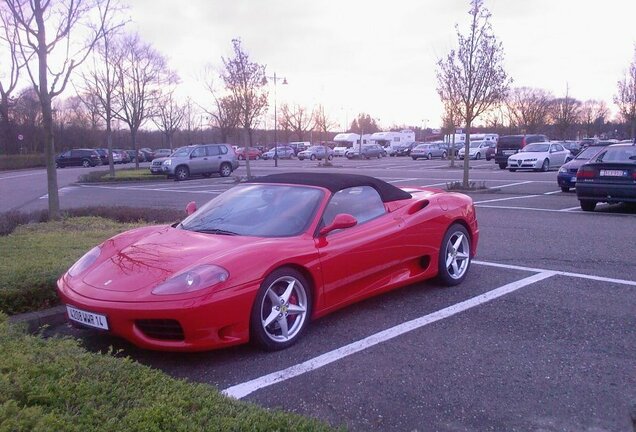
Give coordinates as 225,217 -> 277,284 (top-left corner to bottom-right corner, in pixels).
160,144 -> 239,181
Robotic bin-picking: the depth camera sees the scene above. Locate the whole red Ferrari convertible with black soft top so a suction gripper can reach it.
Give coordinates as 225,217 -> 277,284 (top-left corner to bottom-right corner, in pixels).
58,173 -> 479,351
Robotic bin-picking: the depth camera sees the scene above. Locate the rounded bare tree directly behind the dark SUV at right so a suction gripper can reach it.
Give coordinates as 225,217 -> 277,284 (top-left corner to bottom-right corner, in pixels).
506,87 -> 554,133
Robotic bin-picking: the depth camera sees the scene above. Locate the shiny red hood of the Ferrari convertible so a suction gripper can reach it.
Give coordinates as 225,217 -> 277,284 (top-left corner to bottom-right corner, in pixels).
79,227 -> 266,301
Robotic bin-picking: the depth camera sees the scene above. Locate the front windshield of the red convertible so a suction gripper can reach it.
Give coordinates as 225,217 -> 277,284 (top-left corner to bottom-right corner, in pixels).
178,184 -> 323,237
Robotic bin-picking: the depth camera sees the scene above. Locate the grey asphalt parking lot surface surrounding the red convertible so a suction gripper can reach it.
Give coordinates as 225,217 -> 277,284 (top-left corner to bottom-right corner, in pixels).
0,158 -> 636,431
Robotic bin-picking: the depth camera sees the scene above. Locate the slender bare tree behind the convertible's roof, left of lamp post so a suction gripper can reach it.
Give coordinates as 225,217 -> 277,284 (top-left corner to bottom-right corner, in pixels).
221,39 -> 268,178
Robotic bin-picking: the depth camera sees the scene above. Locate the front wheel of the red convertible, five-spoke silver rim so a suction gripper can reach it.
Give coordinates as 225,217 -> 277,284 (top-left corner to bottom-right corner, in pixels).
250,267 -> 311,351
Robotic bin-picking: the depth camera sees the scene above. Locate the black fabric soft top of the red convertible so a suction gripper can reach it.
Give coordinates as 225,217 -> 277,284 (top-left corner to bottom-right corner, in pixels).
250,173 -> 412,202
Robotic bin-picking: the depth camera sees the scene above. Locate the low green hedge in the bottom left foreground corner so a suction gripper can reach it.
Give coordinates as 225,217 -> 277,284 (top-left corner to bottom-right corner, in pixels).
0,313 -> 338,432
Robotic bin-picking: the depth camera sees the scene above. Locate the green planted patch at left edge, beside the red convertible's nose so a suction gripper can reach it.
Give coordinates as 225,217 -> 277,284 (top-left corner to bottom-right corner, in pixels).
0,217 -> 140,315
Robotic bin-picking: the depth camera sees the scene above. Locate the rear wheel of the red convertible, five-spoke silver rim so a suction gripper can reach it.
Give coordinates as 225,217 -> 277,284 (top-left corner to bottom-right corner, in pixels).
437,224 -> 471,286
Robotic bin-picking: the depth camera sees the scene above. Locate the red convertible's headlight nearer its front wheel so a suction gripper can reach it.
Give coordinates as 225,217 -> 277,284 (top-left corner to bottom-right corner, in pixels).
152,265 -> 230,295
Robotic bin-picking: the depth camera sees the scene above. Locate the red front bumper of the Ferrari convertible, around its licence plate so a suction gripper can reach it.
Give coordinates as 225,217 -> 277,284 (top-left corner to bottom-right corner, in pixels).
57,277 -> 258,351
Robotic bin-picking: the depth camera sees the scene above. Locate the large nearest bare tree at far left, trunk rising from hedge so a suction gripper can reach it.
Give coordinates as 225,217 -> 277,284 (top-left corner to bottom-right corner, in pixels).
5,0 -> 115,219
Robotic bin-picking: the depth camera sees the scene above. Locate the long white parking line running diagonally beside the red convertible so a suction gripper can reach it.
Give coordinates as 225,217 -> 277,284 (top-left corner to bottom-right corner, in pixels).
222,271 -> 556,399
